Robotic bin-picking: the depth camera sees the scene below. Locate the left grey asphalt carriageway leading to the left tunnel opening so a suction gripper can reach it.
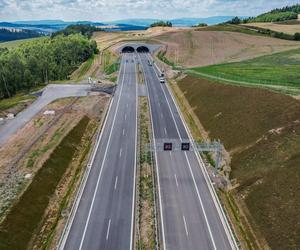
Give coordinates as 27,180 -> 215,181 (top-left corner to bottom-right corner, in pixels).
60,54 -> 137,250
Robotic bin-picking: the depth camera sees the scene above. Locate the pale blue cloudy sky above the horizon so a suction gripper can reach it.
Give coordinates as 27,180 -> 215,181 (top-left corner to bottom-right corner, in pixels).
0,0 -> 300,21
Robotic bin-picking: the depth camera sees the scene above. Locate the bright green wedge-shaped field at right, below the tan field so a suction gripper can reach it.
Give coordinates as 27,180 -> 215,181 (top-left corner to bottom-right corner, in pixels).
192,49 -> 300,93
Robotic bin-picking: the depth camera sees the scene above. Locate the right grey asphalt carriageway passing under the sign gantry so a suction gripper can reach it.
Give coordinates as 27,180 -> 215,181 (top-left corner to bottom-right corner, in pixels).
140,54 -> 236,250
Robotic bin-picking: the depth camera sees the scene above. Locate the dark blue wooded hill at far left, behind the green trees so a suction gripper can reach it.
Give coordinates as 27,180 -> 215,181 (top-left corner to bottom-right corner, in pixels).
0,28 -> 41,42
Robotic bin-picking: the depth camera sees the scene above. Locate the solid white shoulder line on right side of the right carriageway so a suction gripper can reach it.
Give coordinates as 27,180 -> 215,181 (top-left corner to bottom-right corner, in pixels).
146,53 -> 217,250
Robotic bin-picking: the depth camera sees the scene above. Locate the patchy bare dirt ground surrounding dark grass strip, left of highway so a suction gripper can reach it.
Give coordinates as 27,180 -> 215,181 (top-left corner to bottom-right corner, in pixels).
0,94 -> 110,249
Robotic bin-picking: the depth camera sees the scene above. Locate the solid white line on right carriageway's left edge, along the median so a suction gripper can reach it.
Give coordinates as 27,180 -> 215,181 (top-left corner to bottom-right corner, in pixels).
139,55 -> 167,250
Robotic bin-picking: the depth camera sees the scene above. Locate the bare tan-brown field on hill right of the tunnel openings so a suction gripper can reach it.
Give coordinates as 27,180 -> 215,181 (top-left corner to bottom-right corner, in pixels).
154,30 -> 300,67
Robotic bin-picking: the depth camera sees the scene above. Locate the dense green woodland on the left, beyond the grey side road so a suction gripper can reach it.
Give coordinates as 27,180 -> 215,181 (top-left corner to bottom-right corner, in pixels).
0,34 -> 98,99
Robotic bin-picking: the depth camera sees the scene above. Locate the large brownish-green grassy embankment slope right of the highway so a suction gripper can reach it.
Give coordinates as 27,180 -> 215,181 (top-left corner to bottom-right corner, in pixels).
178,76 -> 300,250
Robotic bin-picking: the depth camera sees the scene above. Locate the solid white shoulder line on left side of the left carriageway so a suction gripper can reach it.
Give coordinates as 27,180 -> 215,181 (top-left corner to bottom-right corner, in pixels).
79,55 -> 126,250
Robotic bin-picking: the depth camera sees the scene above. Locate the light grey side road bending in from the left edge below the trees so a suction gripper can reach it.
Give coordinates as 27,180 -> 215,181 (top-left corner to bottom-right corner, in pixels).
0,84 -> 91,147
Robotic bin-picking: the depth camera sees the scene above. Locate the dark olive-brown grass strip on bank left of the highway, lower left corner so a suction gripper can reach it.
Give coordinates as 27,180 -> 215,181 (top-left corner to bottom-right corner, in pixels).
0,116 -> 89,249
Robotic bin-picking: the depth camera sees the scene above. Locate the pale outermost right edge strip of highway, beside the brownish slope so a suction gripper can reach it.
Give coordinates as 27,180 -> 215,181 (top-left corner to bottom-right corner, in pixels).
154,56 -> 239,249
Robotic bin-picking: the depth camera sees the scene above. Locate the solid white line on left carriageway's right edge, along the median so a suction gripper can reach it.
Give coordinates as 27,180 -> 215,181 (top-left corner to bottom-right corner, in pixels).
130,52 -> 138,249
